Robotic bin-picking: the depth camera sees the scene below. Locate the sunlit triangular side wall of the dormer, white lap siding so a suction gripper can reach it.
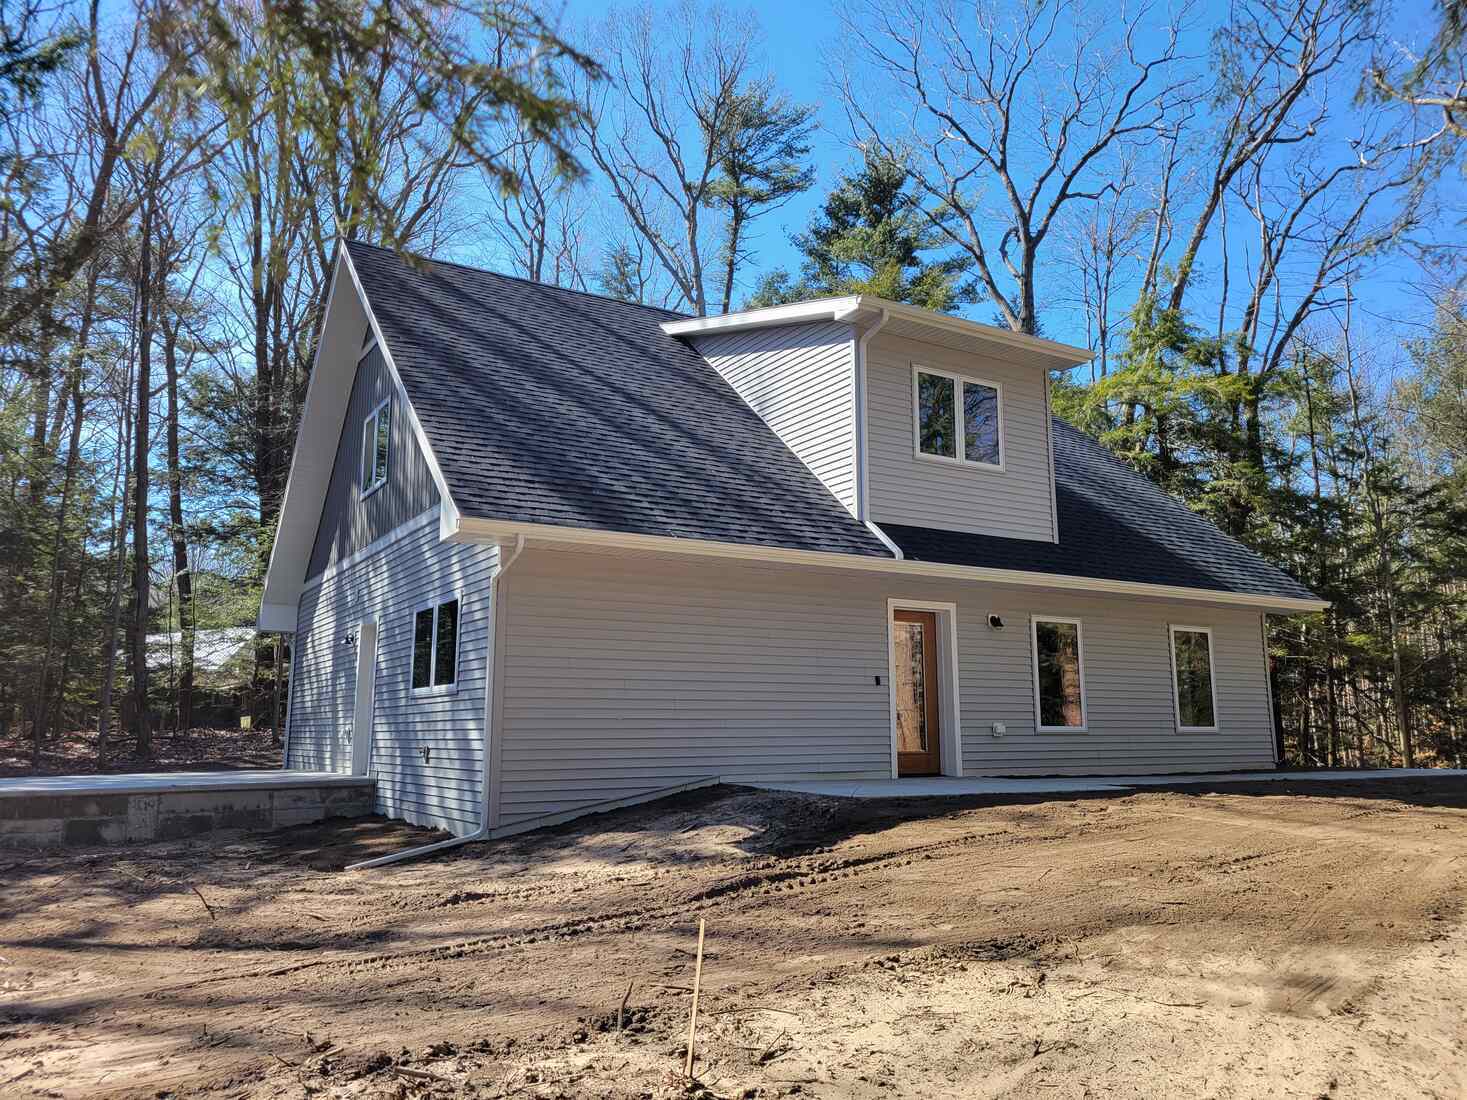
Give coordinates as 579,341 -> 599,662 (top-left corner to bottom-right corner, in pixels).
692,321 -> 857,513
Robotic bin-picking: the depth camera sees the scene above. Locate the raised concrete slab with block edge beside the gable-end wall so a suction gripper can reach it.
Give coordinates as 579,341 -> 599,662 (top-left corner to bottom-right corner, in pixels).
0,769 -> 376,848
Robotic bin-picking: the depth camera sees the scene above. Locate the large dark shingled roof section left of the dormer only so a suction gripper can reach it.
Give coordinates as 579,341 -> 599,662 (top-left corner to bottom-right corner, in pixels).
348,242 -> 890,557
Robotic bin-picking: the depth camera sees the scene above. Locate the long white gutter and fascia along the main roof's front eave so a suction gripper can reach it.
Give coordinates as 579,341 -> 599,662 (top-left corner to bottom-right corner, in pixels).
449,516 -> 1329,615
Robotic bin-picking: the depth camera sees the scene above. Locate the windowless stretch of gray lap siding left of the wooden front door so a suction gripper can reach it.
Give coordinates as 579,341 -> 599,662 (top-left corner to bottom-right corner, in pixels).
499,550 -> 890,826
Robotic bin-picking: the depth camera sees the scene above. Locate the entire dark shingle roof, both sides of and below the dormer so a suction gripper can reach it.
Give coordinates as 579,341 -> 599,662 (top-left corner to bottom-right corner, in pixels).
348,242 -> 1311,598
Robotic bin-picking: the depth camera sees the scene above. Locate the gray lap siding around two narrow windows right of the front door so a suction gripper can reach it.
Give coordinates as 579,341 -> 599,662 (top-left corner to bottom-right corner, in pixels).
959,590 -> 1273,774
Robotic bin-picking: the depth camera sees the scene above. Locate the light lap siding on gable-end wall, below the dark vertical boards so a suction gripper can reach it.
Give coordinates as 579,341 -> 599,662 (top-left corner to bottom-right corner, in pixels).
286,522 -> 499,835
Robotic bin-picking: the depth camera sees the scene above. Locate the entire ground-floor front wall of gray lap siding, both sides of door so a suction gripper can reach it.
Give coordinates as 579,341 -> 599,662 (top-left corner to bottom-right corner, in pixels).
499,549 -> 1273,826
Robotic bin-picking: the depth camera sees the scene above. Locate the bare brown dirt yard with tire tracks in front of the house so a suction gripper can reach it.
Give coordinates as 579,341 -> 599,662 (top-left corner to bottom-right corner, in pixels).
0,779 -> 1467,1099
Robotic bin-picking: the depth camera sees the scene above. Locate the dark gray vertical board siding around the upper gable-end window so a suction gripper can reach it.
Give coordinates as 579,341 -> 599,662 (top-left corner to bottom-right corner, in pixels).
305,348 -> 439,578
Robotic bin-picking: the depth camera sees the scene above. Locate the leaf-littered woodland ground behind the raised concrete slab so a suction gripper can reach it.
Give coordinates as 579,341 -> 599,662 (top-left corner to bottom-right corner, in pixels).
0,729 -> 280,777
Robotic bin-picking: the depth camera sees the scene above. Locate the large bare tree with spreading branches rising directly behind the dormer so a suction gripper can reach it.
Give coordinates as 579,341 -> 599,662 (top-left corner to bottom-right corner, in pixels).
835,0 -> 1196,333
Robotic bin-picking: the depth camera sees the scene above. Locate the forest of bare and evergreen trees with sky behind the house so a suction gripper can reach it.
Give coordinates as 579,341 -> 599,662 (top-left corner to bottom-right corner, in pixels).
0,0 -> 1467,766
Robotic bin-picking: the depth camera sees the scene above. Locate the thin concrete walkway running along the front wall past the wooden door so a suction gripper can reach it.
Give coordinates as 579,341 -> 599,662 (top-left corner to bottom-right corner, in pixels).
748,767 -> 1467,798
